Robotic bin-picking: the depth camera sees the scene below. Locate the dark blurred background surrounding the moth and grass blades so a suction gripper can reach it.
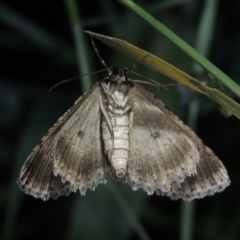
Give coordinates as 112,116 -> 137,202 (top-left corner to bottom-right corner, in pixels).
0,0 -> 240,240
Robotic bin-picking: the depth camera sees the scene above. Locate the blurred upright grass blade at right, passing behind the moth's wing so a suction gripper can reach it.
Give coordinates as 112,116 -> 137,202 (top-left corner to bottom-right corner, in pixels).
180,0 -> 217,240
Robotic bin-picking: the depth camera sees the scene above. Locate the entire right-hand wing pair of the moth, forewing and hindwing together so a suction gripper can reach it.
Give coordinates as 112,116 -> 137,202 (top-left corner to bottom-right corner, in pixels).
127,84 -> 230,199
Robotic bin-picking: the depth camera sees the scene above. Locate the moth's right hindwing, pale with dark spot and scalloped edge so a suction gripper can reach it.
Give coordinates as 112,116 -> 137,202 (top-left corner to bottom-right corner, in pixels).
126,84 -> 199,193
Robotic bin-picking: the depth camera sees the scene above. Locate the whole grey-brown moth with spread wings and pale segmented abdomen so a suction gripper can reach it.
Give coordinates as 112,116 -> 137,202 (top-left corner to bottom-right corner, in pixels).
18,41 -> 230,200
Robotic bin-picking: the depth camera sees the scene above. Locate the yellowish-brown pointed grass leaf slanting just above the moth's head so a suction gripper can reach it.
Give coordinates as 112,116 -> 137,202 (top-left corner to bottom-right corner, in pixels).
86,31 -> 240,119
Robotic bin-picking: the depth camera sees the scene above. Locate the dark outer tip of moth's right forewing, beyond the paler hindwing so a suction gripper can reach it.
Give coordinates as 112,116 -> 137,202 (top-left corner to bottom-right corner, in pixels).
156,146 -> 230,200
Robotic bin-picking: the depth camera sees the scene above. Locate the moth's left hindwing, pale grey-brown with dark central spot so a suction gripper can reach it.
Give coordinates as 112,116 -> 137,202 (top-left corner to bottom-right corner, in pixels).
53,85 -> 110,195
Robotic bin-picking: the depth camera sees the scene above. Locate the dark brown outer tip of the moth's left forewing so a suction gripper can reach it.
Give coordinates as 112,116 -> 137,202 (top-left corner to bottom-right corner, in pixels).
18,135 -> 70,200
